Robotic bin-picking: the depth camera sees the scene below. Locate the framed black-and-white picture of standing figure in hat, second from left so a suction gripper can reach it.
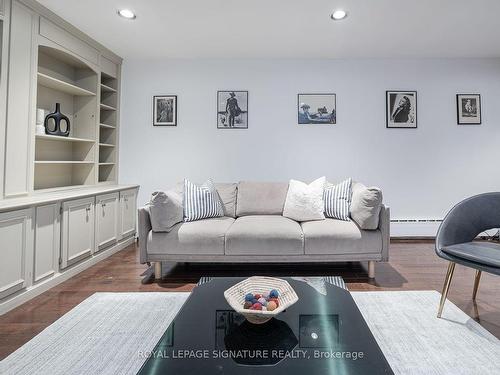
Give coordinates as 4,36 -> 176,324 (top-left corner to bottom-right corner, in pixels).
217,91 -> 248,129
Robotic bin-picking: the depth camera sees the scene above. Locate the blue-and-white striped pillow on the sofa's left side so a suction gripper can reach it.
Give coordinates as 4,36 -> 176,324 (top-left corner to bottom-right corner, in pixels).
183,179 -> 224,222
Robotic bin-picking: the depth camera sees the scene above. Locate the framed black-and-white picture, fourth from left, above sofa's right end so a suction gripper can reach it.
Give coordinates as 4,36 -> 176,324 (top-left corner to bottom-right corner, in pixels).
386,91 -> 417,129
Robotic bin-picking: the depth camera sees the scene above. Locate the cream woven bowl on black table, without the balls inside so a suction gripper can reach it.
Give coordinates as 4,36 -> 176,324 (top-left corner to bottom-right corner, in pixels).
224,276 -> 299,324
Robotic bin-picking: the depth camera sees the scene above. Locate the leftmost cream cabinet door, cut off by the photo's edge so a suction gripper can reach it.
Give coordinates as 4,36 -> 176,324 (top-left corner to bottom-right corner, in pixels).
0,209 -> 33,299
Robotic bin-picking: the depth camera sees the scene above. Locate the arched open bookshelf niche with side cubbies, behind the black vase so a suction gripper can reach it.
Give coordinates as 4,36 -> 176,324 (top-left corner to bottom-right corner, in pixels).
34,45 -> 119,191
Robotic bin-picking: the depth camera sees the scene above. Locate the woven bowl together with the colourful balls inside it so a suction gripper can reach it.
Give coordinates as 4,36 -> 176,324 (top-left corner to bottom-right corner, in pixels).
224,276 -> 299,324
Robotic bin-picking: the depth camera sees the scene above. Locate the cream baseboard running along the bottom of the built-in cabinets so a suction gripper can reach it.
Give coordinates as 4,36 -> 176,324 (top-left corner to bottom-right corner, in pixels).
0,237 -> 135,315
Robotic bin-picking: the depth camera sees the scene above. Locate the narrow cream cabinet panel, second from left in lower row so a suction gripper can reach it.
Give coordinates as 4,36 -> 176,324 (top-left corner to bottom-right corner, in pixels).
34,203 -> 61,283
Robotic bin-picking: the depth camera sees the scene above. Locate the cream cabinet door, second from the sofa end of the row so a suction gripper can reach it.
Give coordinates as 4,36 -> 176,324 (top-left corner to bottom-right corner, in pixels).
95,193 -> 119,250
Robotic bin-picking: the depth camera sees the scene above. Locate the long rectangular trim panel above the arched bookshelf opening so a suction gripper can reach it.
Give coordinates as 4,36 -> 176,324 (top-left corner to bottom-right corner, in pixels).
40,17 -> 99,65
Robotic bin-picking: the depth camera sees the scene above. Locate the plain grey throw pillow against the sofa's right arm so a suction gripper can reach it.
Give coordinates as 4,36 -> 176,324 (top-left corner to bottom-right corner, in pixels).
351,182 -> 382,230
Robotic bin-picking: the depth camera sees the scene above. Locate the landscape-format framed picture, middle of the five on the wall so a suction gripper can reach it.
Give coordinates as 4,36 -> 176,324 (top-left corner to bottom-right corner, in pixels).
297,94 -> 337,124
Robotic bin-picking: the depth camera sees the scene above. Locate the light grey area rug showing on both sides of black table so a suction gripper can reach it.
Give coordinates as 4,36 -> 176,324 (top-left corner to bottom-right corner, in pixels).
0,291 -> 500,375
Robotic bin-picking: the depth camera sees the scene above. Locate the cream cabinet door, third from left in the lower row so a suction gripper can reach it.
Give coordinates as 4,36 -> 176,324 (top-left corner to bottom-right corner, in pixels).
61,197 -> 94,268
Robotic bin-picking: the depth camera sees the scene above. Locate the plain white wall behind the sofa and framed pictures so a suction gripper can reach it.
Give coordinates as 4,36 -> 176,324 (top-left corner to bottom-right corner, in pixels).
120,58 -> 500,235
